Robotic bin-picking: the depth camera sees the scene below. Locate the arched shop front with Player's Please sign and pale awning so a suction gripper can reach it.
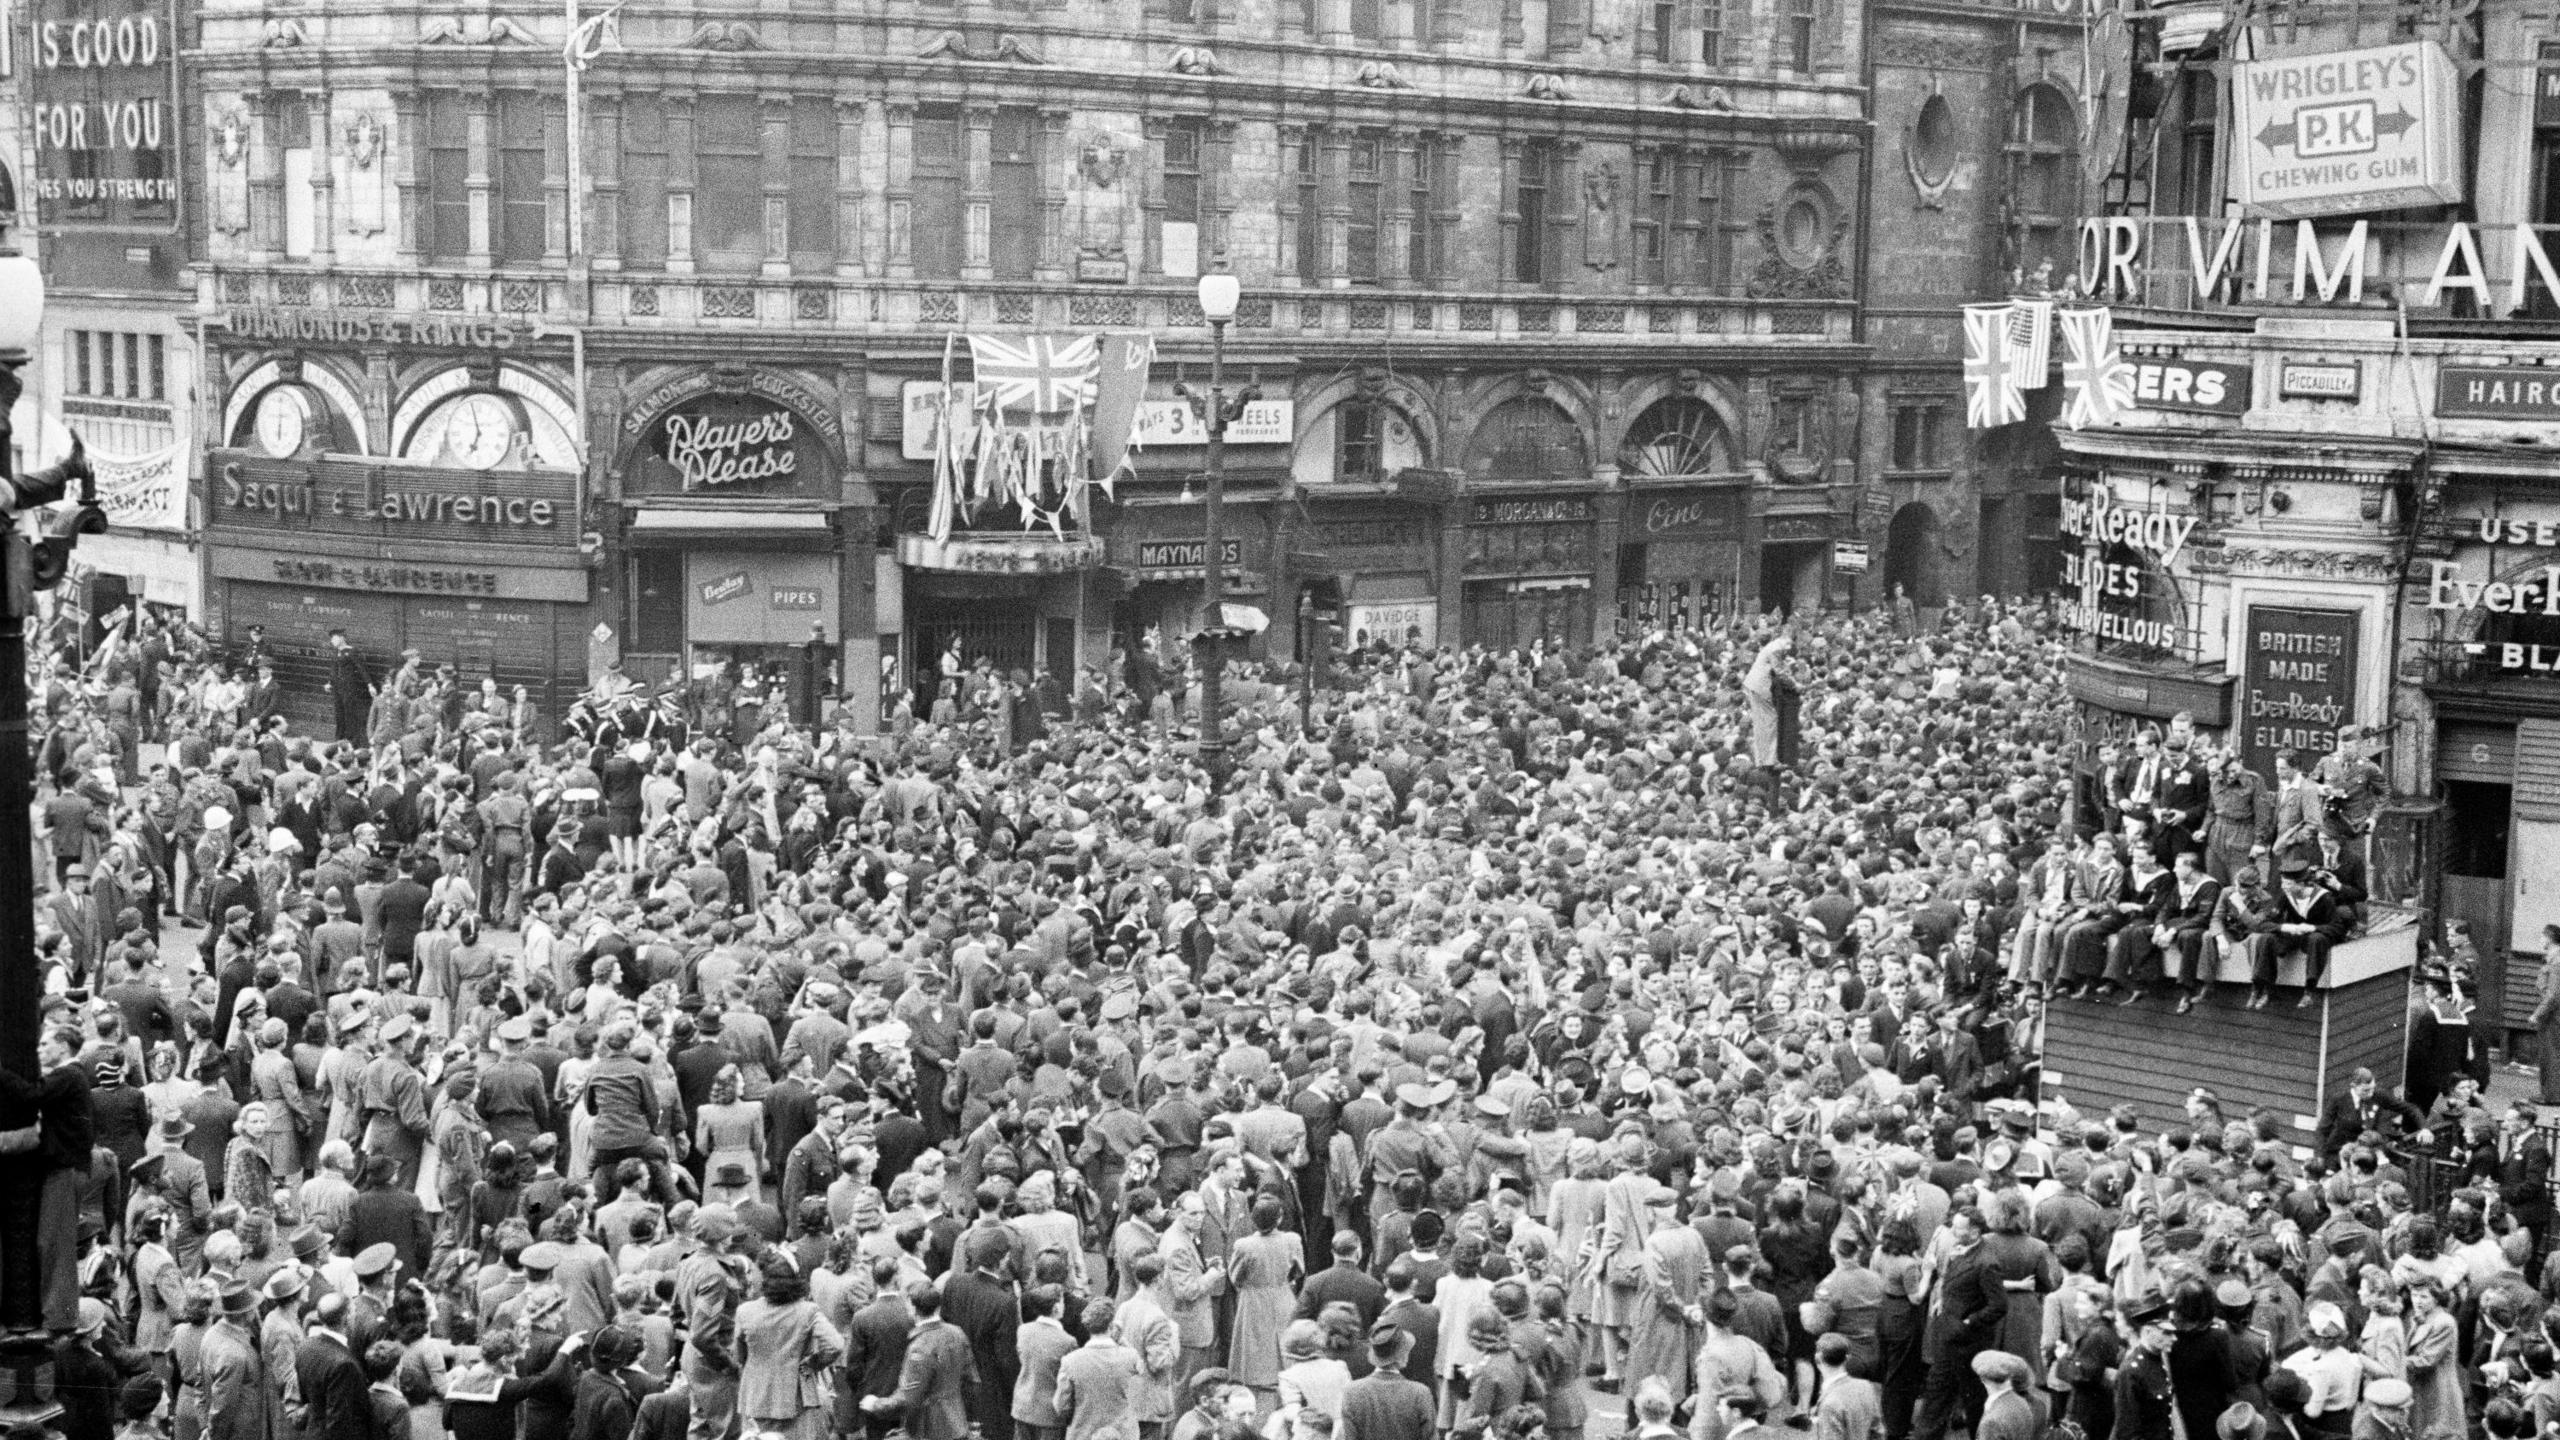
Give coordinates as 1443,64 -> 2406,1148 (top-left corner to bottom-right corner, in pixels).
620,366 -> 873,730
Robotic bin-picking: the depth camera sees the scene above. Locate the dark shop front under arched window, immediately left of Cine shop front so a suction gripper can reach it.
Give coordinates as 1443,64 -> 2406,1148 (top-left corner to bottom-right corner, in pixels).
1459,495 -> 1600,651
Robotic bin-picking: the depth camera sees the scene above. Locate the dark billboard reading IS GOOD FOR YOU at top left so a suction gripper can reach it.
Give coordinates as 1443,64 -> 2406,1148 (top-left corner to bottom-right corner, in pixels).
24,0 -> 176,231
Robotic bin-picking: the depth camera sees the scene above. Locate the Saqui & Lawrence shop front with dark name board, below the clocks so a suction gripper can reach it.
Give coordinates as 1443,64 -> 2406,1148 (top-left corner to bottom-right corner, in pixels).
205,451 -> 589,735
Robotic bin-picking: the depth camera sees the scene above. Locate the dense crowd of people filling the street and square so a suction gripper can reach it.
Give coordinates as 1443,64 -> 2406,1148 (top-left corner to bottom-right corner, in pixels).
0,600 -> 2519,1440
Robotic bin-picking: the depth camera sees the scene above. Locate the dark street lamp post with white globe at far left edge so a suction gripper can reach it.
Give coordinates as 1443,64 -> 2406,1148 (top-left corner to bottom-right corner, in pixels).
0,236 -> 108,1425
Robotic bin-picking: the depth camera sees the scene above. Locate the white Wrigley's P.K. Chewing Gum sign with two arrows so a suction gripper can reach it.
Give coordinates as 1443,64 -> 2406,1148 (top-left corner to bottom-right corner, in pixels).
2232,41 -> 2463,218
